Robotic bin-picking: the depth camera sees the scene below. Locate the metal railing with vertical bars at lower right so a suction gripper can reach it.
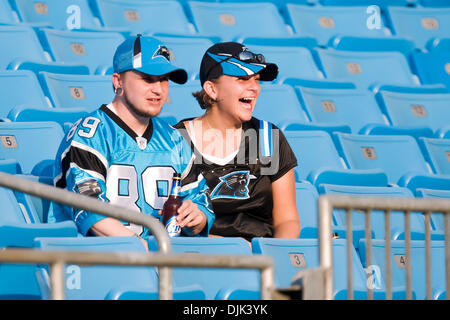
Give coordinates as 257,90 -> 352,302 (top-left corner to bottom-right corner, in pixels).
318,195 -> 450,300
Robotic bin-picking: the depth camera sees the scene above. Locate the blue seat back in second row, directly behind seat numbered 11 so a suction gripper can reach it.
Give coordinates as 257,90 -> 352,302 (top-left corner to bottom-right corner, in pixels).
316,49 -> 418,89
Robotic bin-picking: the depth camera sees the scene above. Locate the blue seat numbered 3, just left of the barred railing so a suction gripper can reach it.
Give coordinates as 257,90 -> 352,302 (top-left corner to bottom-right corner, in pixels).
252,238 -> 400,300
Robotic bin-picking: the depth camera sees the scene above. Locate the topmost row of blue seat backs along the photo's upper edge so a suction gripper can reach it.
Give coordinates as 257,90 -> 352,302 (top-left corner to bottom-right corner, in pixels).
2,0 -> 448,47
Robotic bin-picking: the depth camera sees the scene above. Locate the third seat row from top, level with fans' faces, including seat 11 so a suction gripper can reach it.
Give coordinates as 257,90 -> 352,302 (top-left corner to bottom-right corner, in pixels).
0,70 -> 450,138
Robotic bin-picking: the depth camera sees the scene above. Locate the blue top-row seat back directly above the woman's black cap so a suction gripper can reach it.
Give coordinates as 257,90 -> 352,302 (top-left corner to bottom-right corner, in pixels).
189,1 -> 291,41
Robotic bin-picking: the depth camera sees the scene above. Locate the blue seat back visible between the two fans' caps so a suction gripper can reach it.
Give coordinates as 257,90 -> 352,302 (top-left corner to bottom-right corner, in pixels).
156,36 -> 214,80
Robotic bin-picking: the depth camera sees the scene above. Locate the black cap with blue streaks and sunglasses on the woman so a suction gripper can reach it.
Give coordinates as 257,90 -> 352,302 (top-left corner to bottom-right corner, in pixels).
200,42 -> 278,87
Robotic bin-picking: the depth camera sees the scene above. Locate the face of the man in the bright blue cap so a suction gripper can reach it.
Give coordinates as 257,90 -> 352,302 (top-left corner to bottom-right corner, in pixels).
121,71 -> 169,117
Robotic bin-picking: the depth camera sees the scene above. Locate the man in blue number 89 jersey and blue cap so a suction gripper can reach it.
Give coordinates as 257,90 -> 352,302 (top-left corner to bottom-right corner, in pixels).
49,35 -> 214,244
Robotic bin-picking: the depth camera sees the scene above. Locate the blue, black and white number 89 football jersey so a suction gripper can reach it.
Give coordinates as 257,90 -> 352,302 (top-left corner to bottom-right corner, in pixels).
48,105 -> 215,236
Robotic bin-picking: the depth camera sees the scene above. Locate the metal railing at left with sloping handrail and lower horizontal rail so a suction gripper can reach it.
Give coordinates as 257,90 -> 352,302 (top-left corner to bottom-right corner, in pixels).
0,172 -> 274,300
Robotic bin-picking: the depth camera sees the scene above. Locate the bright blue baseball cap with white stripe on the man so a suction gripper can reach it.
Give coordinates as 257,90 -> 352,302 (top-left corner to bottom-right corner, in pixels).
113,34 -> 188,84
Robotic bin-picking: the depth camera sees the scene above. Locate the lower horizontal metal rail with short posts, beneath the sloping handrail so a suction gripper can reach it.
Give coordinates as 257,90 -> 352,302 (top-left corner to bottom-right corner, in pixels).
0,249 -> 274,300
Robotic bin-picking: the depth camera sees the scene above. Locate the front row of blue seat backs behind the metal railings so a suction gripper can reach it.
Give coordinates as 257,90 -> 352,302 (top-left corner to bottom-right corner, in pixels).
0,232 -> 445,300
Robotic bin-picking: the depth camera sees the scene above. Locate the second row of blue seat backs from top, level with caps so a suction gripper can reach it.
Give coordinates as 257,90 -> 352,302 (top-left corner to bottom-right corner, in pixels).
0,22 -> 450,87
